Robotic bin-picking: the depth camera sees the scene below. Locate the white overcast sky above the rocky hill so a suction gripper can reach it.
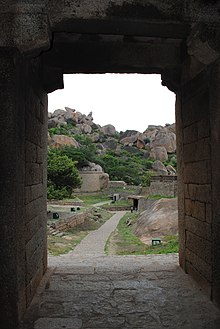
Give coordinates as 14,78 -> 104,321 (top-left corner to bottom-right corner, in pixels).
49,74 -> 175,132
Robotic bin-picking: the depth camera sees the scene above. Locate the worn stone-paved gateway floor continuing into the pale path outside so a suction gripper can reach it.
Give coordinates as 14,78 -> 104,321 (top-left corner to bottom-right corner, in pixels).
21,214 -> 220,329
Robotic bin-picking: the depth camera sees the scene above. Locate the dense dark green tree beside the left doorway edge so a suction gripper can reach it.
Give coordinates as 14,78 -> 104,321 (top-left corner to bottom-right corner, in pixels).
47,150 -> 81,198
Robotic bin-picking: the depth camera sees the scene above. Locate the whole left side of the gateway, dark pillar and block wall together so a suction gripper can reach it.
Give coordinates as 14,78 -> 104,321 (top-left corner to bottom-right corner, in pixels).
0,47 -> 47,329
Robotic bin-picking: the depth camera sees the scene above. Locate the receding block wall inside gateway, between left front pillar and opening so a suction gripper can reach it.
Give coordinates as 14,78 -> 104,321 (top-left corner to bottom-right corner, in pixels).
25,70 -> 47,305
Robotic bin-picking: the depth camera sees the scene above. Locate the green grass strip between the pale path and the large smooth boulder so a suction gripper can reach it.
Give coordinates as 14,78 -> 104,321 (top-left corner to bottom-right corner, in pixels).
105,213 -> 178,255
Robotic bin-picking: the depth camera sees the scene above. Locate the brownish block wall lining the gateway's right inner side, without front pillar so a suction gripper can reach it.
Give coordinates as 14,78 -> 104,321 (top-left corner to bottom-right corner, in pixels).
177,58 -> 213,296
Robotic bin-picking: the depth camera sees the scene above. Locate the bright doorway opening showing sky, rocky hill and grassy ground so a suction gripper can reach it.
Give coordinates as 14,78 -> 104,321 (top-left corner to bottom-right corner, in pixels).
48,74 -> 178,255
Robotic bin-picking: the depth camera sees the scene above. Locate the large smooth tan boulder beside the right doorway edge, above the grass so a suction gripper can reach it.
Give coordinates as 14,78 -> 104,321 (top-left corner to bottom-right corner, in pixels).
135,198 -> 178,244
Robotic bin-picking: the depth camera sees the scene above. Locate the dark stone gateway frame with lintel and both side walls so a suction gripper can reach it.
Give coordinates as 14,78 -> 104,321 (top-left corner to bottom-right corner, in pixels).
0,0 -> 220,328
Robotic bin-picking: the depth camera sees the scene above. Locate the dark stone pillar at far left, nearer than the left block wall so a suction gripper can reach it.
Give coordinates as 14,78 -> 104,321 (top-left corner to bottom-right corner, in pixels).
0,48 -> 25,328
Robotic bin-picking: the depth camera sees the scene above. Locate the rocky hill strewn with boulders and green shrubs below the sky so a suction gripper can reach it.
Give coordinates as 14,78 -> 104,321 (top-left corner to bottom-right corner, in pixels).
48,107 -> 176,183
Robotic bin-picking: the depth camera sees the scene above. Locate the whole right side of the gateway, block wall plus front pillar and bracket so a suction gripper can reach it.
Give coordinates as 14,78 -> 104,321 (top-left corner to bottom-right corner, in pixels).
177,24 -> 220,305
